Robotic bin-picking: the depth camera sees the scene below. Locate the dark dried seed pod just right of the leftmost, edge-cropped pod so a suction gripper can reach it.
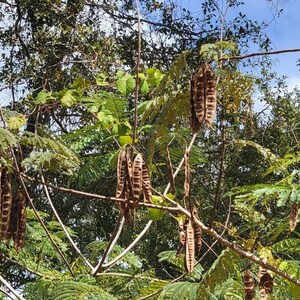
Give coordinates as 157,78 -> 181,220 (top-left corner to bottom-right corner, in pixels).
11,193 -> 26,251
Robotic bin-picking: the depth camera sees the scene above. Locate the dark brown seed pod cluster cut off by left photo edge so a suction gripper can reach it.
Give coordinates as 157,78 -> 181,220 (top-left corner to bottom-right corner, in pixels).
0,167 -> 26,250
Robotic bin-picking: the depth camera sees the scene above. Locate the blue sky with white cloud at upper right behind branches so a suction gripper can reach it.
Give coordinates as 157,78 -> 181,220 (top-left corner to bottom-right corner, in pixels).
182,0 -> 300,88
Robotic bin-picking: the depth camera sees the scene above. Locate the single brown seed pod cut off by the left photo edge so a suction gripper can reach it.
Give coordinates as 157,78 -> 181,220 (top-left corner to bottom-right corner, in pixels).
0,168 -> 12,239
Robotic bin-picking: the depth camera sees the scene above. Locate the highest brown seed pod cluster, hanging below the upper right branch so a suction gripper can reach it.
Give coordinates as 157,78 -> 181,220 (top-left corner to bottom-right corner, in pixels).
190,63 -> 217,132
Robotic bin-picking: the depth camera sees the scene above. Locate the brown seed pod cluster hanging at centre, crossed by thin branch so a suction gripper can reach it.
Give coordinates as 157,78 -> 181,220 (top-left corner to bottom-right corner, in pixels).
116,148 -> 152,220
